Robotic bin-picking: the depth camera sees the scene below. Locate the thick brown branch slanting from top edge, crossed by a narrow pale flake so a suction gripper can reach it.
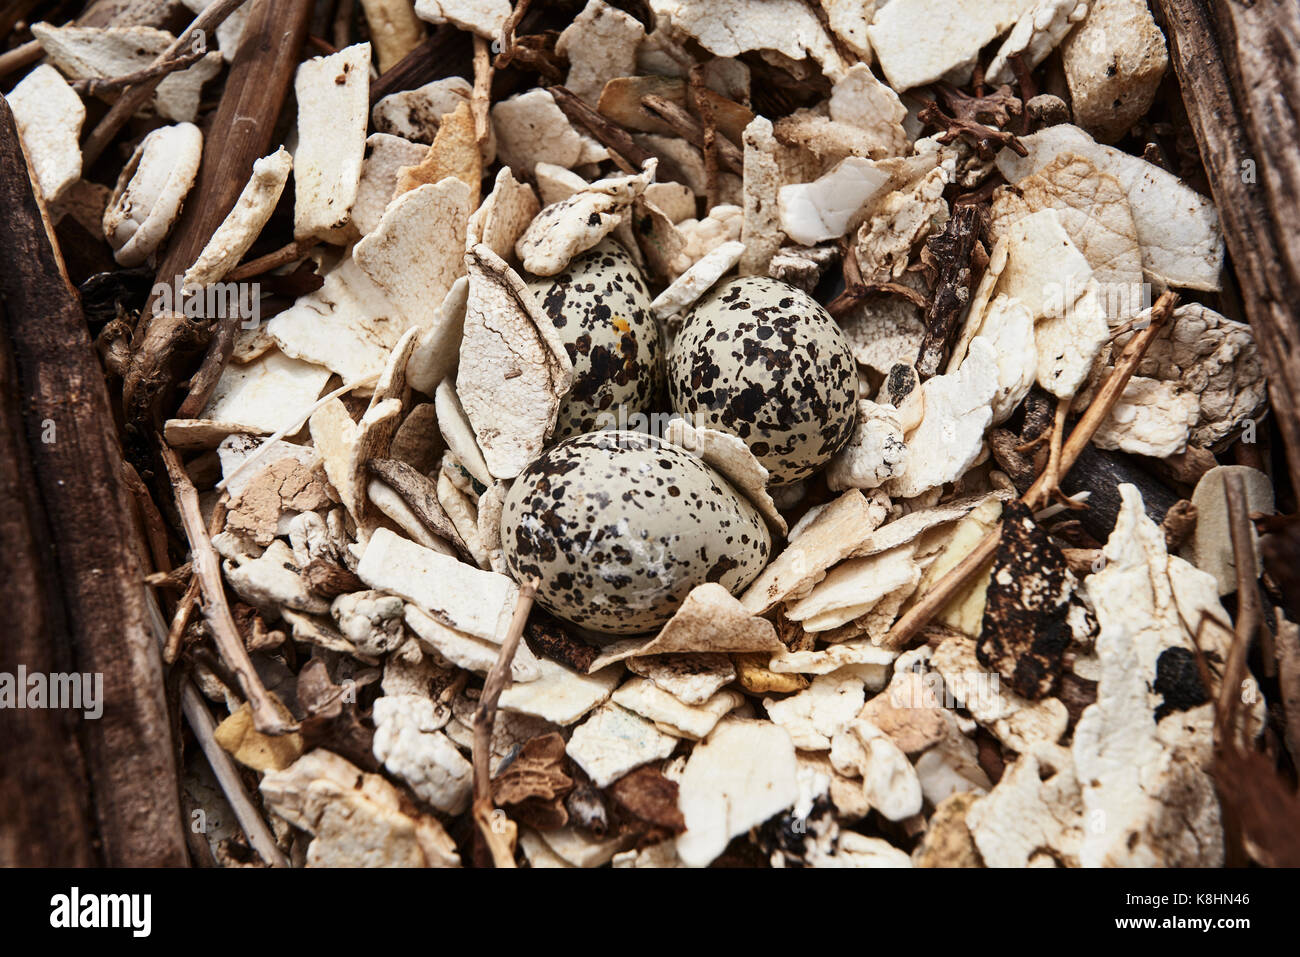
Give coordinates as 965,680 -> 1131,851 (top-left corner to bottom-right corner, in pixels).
124,0 -> 312,475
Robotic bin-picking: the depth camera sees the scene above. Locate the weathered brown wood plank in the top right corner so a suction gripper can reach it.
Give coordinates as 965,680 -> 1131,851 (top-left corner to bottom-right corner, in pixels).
1160,0 -> 1300,486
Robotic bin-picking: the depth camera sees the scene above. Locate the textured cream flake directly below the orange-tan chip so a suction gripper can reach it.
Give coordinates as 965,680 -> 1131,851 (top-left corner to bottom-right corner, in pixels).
352,177 -> 469,328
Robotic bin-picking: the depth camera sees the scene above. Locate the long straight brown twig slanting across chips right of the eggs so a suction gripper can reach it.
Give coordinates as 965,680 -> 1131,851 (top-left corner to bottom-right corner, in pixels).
880,293 -> 1178,649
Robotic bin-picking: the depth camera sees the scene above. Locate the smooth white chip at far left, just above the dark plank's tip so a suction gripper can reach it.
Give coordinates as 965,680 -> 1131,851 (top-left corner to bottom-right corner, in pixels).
5,64 -> 86,203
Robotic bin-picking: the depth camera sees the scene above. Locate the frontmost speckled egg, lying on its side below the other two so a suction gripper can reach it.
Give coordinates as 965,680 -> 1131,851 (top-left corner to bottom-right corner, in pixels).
501,429 -> 772,635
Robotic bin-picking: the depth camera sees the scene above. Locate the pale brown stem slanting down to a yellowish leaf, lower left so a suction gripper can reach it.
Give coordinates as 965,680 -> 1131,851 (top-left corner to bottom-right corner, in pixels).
159,437 -> 294,735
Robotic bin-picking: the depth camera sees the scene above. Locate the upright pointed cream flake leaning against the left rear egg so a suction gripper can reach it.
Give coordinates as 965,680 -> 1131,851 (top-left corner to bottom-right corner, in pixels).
456,241 -> 573,479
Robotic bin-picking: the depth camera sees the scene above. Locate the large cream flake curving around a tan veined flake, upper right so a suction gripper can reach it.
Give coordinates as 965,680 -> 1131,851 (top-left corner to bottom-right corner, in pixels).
997,124 -> 1223,290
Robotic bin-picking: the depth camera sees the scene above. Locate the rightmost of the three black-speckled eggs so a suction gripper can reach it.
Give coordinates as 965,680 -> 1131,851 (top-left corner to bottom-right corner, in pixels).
668,276 -> 858,485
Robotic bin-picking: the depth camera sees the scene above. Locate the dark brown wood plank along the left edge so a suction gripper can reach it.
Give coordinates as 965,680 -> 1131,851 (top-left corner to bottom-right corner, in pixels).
0,98 -> 187,866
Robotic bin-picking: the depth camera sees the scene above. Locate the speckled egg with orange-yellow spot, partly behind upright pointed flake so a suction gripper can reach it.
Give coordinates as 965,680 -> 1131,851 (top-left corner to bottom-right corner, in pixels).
528,239 -> 663,439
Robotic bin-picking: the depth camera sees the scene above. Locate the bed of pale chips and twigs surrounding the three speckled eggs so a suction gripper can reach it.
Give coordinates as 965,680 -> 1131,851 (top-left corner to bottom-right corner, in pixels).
0,0 -> 1300,867
